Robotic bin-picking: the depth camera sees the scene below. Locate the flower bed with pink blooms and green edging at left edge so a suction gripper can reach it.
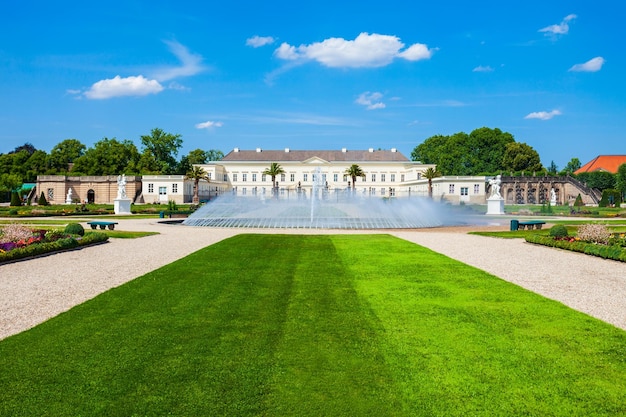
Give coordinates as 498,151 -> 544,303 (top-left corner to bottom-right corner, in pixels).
0,224 -> 109,263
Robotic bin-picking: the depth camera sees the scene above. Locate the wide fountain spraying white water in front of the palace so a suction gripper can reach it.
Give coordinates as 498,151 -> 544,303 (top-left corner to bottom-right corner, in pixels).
183,170 -> 468,229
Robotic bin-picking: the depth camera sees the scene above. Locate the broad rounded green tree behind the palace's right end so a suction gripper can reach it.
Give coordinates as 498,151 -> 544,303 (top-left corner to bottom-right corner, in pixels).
411,127 -> 515,175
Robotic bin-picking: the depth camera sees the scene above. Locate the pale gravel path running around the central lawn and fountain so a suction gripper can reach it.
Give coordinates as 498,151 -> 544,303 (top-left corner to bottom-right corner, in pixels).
0,219 -> 626,339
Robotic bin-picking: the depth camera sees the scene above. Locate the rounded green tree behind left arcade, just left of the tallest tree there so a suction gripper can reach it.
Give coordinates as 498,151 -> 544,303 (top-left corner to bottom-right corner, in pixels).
72,138 -> 140,175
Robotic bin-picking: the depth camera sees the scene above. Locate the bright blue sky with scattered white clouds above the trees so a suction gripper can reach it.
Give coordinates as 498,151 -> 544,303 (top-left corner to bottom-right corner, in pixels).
0,0 -> 626,168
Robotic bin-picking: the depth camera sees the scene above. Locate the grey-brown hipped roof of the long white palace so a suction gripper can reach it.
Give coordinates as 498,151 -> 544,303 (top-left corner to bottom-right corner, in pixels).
222,149 -> 409,162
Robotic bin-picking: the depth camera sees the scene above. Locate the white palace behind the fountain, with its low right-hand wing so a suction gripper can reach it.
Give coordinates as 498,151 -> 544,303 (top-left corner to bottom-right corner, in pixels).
180,148 -> 485,204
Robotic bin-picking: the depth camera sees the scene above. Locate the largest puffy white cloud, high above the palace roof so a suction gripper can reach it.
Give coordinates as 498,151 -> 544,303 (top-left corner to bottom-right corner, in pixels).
274,33 -> 436,68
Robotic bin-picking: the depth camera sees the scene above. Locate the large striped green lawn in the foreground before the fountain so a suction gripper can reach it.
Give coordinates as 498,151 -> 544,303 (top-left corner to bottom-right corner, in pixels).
0,235 -> 626,416
